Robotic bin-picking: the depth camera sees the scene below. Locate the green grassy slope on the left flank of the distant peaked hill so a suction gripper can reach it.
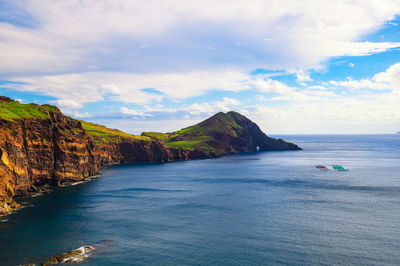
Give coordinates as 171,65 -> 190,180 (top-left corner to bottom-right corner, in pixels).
143,112 -> 246,152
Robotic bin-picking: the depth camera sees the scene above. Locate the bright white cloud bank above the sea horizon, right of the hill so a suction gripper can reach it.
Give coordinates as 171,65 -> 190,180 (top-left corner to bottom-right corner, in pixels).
250,63 -> 400,134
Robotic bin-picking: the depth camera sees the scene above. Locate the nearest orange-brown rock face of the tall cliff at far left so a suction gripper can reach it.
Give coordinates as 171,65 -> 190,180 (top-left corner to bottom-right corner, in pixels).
0,107 -> 101,213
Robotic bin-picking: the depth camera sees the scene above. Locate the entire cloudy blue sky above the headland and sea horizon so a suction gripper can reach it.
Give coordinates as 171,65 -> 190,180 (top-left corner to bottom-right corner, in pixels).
0,0 -> 400,134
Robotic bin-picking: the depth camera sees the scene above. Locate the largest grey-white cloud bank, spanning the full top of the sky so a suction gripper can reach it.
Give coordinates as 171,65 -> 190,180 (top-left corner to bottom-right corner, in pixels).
0,0 -> 400,75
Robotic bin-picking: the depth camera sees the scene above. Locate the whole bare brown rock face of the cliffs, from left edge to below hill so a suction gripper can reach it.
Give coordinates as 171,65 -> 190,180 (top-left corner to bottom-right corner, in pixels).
0,98 -> 214,216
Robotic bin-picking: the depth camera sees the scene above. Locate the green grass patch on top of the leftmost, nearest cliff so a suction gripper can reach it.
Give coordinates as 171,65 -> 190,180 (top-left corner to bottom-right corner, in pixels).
0,101 -> 58,121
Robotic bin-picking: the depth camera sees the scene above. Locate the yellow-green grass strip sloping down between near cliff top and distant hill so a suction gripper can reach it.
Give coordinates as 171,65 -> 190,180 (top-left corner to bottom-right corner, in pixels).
81,121 -> 151,143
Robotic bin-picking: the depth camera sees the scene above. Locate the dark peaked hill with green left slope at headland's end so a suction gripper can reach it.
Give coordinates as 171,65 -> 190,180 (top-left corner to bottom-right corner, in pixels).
142,111 -> 300,155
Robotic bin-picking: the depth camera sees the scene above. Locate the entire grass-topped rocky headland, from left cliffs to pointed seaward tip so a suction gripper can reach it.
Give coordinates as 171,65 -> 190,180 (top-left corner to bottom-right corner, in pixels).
0,96 -> 299,216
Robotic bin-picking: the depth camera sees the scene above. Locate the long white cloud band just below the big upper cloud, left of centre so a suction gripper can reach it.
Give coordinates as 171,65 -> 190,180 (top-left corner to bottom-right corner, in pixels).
6,70 -> 248,105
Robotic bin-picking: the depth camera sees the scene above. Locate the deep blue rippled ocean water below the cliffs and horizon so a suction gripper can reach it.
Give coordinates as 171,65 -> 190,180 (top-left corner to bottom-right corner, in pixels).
0,135 -> 400,265
